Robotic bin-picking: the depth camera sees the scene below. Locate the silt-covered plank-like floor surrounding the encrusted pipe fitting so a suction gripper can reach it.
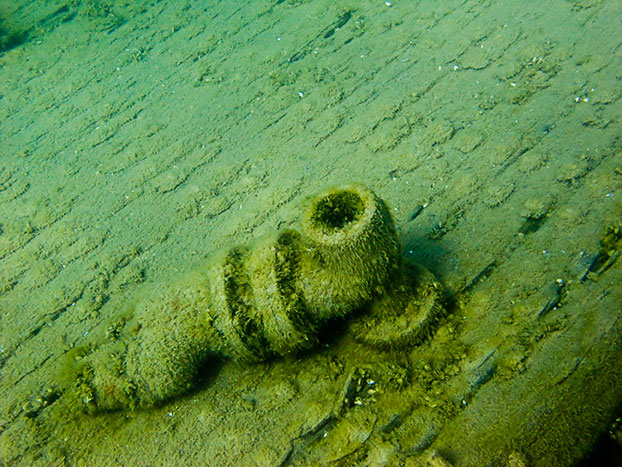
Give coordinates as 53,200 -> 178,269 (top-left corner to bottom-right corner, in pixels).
0,0 -> 622,465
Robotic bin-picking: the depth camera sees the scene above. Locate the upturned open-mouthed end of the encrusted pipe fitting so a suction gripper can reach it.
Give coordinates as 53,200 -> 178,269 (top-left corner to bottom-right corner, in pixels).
301,185 -> 400,320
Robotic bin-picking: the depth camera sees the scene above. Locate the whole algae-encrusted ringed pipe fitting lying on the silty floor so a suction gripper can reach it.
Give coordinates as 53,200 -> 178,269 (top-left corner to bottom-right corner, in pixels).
62,185 -> 438,412
